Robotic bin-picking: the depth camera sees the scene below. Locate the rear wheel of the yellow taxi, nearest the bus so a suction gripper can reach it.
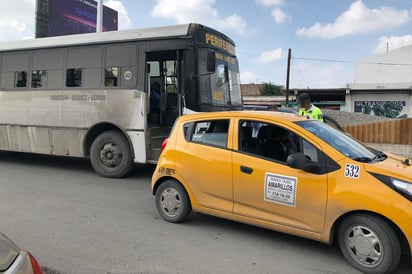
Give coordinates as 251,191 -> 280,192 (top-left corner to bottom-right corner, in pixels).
156,180 -> 192,223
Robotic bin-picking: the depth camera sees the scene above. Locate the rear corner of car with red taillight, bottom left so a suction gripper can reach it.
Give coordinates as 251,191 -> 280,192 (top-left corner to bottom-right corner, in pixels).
0,232 -> 43,274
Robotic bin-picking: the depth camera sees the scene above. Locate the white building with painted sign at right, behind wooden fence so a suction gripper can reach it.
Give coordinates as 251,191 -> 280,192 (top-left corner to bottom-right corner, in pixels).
345,45 -> 412,117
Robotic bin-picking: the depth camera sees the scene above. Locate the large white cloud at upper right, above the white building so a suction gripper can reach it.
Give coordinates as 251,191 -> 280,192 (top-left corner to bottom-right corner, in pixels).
296,0 -> 410,39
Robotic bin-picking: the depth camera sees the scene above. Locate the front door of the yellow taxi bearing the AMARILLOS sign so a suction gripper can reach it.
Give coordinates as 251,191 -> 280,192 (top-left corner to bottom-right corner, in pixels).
233,121 -> 328,233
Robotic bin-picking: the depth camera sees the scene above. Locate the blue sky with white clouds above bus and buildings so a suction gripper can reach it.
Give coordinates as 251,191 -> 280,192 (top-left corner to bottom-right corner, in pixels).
0,0 -> 412,89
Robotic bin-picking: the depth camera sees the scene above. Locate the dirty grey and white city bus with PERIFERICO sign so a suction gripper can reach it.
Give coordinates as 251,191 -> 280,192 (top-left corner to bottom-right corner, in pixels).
0,23 -> 242,178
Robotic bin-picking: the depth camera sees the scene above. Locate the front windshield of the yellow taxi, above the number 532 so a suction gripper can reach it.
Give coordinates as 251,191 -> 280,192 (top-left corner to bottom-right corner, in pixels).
296,121 -> 385,163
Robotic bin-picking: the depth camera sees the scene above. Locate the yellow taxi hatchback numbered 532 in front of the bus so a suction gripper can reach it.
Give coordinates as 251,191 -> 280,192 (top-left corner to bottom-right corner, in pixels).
152,111 -> 412,273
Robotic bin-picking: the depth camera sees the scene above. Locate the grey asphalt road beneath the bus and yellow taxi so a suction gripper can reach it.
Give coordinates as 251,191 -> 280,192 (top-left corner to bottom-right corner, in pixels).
0,153 -> 411,274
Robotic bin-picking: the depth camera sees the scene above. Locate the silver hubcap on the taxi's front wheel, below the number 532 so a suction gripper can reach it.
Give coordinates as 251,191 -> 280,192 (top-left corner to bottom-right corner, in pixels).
346,226 -> 384,267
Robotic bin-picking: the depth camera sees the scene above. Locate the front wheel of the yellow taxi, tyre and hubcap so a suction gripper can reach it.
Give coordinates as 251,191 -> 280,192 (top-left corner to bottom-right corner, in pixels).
338,215 -> 401,273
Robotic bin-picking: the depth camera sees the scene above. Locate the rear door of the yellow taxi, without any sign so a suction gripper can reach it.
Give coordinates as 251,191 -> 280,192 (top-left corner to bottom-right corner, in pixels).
175,118 -> 233,212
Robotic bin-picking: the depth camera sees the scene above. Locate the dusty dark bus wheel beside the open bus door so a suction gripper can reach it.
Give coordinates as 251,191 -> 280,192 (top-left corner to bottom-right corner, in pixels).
90,131 -> 133,178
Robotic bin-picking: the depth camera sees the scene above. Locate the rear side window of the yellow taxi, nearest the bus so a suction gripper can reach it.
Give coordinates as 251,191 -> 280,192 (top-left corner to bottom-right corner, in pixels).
189,119 -> 229,148
